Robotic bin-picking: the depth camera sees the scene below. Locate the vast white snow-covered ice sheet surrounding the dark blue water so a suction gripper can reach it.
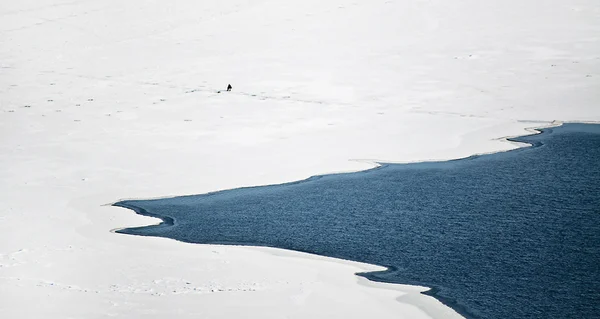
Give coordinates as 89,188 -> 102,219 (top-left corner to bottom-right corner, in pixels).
0,0 -> 600,318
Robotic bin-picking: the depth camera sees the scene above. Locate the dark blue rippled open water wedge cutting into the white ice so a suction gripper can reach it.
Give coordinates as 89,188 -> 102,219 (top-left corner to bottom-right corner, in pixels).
116,124 -> 600,318
